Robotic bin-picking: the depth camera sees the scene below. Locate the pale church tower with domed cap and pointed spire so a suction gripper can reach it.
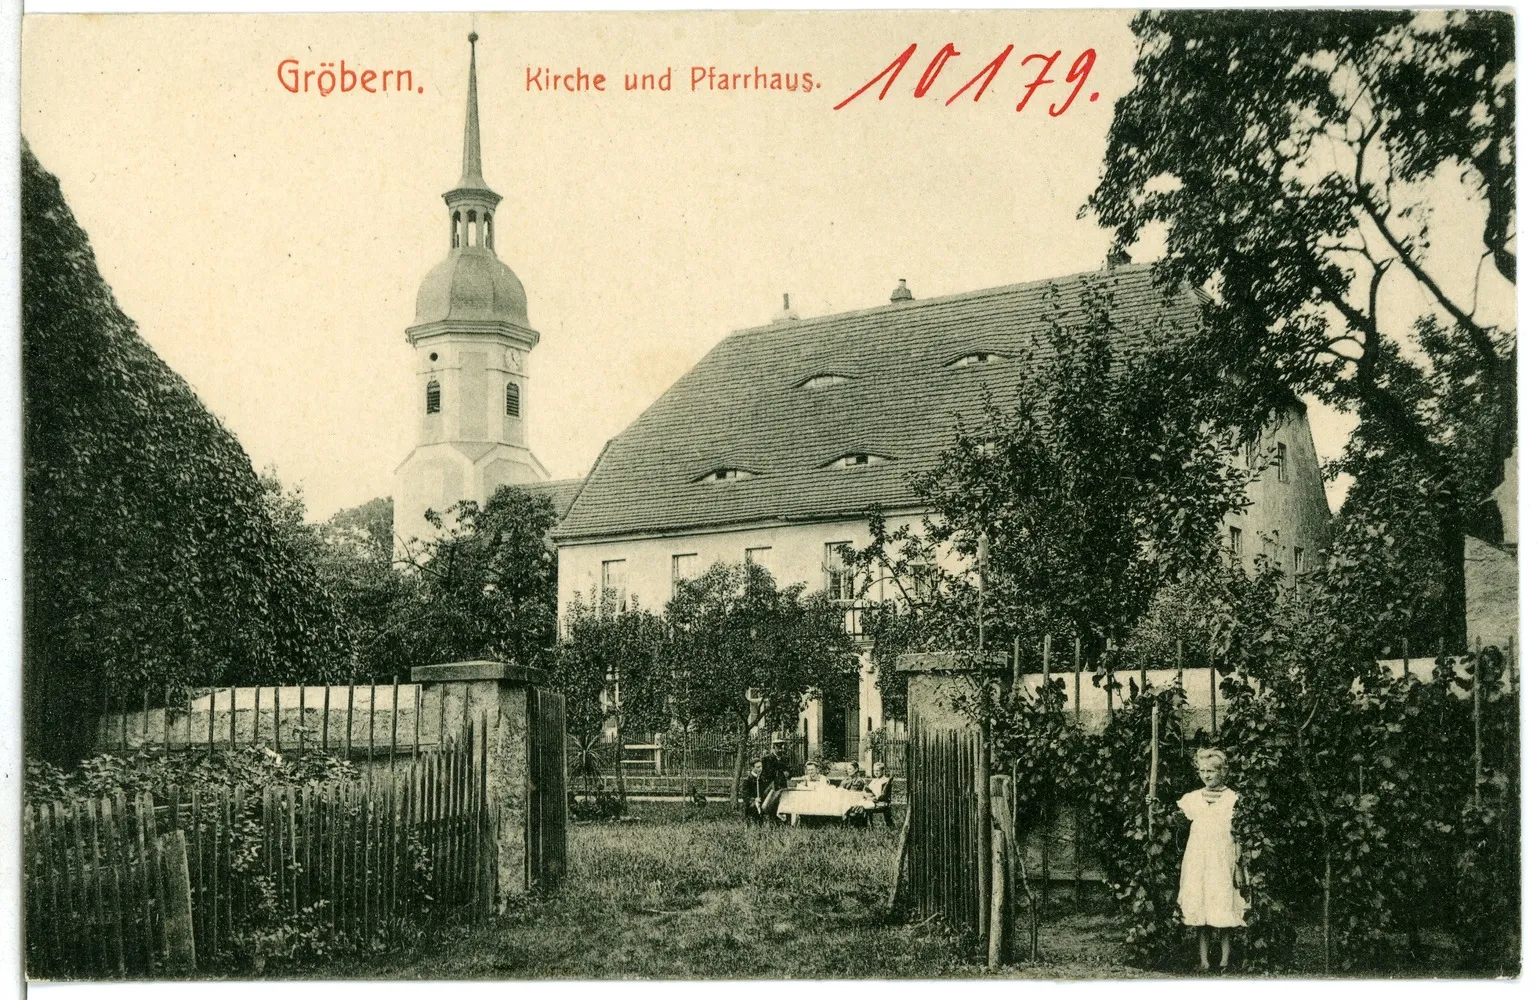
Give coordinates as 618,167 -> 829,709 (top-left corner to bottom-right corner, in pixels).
394,32 -> 549,548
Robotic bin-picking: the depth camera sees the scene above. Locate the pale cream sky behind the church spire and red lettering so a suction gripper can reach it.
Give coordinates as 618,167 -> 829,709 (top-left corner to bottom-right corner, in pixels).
12,11 -> 1482,518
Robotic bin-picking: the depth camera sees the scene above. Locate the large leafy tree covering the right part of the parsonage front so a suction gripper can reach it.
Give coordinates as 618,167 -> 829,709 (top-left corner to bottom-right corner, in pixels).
855,272 -> 1250,655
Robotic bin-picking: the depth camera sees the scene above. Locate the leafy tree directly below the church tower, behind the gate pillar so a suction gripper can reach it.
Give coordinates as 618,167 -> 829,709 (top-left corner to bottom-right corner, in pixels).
387,486 -> 557,668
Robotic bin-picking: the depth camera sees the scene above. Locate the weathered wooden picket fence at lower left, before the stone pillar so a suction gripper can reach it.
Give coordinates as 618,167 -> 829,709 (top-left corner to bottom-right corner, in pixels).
23,718 -> 498,978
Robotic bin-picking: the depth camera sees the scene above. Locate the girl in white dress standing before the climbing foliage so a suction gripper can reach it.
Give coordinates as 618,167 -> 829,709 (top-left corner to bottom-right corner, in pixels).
1180,749 -> 1244,972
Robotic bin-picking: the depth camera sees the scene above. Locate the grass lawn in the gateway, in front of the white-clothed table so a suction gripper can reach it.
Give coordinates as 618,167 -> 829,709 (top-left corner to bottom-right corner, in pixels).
325,803 -> 1147,980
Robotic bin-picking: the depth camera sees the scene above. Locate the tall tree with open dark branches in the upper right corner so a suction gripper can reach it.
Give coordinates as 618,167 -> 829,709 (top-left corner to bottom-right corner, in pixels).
1087,11 -> 1516,645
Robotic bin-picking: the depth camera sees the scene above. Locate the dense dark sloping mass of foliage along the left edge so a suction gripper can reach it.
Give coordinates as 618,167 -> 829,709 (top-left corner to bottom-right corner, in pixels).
22,143 -> 345,760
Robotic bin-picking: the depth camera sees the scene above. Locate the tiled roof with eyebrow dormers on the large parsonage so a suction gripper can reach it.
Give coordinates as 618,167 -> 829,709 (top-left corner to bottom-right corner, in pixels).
554,265 -> 1200,542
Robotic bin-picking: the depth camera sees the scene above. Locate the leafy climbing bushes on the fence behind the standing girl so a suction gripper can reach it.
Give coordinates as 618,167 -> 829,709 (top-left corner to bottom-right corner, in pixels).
992,628 -> 1520,974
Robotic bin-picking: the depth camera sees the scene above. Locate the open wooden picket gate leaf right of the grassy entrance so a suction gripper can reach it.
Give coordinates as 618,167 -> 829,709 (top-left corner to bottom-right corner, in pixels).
900,716 -> 983,935
